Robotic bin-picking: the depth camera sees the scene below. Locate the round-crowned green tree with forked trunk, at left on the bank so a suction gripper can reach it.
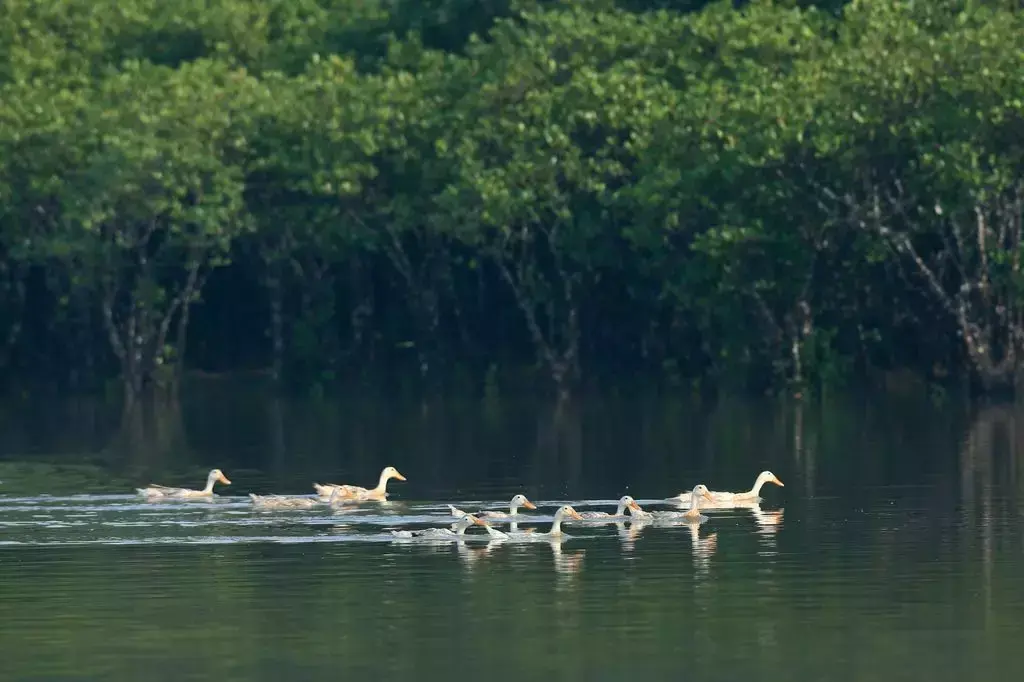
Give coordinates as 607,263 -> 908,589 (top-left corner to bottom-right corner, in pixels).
40,61 -> 255,404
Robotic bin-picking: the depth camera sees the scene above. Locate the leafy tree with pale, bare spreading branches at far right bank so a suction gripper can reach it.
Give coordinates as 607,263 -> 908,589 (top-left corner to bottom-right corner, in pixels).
774,2 -> 1024,390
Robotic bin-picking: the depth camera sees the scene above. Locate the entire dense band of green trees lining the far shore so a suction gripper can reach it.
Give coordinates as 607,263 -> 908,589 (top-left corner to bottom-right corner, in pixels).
0,0 -> 1024,407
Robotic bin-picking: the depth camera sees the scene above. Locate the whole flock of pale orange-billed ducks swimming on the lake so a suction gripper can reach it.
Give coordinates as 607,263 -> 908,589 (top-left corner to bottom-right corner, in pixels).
137,466 -> 783,540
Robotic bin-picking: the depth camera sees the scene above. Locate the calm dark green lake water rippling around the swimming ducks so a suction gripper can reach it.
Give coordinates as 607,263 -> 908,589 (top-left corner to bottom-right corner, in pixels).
0,391 -> 1024,682
